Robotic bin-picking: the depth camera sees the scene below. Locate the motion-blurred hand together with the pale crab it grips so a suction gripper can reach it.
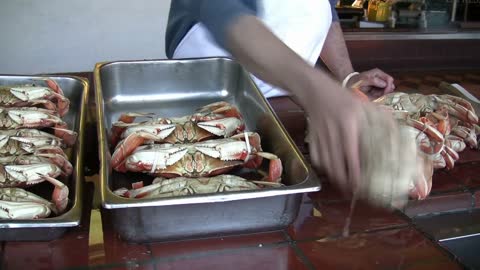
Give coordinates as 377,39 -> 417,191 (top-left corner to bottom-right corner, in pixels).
306,69 -> 414,207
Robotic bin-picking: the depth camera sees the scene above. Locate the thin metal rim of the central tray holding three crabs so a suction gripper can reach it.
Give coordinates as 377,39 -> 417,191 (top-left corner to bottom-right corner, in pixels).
94,57 -> 321,209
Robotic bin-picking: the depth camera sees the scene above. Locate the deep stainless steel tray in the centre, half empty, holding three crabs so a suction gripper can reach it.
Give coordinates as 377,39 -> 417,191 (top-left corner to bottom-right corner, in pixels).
94,58 -> 320,242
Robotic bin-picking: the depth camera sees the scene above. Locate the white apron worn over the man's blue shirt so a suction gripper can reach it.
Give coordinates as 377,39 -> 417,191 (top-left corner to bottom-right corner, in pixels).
173,0 -> 332,98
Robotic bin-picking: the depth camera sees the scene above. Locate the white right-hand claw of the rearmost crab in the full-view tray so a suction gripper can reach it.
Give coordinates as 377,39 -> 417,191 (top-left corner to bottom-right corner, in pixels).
197,117 -> 245,138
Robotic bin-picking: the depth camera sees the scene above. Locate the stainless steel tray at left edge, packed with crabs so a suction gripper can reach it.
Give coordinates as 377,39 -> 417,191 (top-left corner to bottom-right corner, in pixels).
0,75 -> 88,241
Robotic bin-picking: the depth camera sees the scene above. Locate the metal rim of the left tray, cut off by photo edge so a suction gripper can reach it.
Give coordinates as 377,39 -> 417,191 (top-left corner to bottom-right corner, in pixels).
0,74 -> 89,229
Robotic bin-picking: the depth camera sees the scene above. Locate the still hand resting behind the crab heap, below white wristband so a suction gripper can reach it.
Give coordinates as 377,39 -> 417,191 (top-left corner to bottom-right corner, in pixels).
347,68 -> 395,100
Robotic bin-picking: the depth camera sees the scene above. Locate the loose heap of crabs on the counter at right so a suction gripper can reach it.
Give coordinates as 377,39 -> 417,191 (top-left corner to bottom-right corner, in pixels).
374,92 -> 480,199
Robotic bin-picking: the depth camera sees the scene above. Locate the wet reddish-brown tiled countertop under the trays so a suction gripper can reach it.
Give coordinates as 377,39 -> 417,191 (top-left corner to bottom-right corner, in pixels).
0,72 -> 480,270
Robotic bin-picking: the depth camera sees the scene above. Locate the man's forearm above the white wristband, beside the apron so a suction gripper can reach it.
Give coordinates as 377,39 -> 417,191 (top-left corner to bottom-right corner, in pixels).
320,22 -> 353,81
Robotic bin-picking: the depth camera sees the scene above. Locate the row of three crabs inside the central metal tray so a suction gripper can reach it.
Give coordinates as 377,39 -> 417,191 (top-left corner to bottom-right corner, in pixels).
111,101 -> 282,198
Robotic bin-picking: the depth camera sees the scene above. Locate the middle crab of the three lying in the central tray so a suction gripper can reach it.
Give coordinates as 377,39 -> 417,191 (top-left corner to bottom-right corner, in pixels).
120,133 -> 282,181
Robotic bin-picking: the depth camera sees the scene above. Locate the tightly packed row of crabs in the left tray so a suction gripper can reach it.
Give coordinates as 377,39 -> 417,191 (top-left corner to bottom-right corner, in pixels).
0,79 -> 77,219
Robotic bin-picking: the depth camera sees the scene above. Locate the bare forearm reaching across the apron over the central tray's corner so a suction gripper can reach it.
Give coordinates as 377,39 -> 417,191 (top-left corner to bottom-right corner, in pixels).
226,16 -> 338,106
